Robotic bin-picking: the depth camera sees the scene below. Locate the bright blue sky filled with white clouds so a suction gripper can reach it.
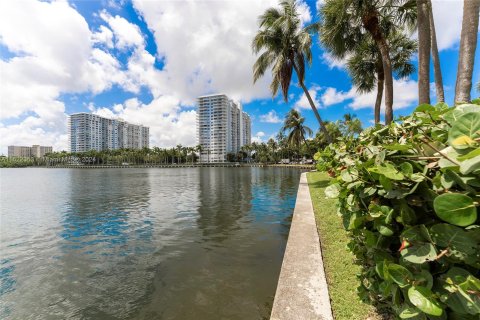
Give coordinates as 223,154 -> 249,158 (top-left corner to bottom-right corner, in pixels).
0,0 -> 480,154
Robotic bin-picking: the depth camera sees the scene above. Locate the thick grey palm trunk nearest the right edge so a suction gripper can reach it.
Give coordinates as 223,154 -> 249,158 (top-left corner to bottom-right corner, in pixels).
455,0 -> 480,104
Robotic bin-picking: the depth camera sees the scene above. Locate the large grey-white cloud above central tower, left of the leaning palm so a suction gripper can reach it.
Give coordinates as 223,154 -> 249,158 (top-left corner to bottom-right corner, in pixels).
133,0 -> 277,104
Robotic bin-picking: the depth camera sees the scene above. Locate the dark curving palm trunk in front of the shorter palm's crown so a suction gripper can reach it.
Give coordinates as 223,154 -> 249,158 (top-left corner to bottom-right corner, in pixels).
362,11 -> 393,124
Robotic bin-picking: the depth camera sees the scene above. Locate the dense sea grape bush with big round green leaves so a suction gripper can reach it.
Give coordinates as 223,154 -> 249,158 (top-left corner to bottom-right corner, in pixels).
315,104 -> 480,319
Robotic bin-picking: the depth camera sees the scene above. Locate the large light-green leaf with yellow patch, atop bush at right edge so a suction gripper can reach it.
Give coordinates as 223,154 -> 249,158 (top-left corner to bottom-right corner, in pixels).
448,112 -> 480,149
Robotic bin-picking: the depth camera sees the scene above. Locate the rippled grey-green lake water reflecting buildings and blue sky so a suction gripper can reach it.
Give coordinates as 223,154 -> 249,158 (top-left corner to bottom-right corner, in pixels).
0,168 -> 300,320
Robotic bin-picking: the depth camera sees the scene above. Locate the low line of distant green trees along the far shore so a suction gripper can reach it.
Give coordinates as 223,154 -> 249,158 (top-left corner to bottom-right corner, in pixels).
0,109 -> 362,167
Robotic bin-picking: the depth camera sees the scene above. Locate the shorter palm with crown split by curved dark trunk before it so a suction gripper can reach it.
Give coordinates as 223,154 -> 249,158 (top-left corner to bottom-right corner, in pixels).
347,32 -> 417,123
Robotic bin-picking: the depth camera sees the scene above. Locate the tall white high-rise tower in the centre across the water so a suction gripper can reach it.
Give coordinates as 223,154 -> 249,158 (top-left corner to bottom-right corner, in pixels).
197,94 -> 252,162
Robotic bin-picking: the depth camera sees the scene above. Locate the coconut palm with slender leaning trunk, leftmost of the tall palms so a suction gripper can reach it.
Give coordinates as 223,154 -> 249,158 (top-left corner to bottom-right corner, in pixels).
252,0 -> 328,141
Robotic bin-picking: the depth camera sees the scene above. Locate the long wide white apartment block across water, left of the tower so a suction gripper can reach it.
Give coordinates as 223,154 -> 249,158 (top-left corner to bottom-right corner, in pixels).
68,112 -> 150,152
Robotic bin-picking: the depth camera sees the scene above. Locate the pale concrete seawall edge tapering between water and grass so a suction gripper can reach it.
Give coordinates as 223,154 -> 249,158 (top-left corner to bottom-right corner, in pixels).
270,173 -> 333,320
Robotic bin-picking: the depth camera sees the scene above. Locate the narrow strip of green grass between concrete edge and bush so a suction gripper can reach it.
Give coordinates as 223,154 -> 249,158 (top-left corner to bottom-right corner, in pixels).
307,172 -> 382,320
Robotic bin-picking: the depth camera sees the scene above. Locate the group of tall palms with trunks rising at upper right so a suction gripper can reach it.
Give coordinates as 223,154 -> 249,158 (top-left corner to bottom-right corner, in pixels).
252,0 -> 480,129
